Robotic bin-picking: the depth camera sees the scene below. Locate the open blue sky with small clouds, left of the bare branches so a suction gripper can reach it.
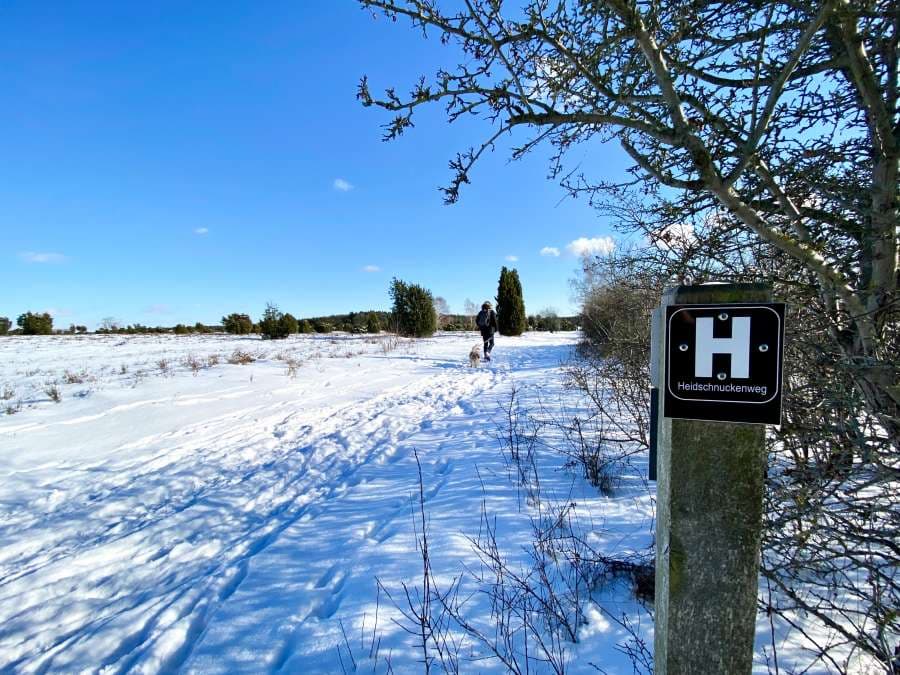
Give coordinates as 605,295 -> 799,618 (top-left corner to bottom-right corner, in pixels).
0,0 -> 626,326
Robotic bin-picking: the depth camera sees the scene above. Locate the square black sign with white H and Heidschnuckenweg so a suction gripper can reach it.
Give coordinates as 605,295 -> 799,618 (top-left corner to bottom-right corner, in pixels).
663,303 -> 784,424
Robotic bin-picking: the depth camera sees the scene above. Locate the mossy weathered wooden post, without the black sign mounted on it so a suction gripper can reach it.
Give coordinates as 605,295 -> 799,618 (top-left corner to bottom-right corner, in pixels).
651,284 -> 780,675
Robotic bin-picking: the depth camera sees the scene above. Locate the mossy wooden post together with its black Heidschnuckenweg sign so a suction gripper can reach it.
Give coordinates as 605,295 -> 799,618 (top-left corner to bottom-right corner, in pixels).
651,284 -> 784,675
